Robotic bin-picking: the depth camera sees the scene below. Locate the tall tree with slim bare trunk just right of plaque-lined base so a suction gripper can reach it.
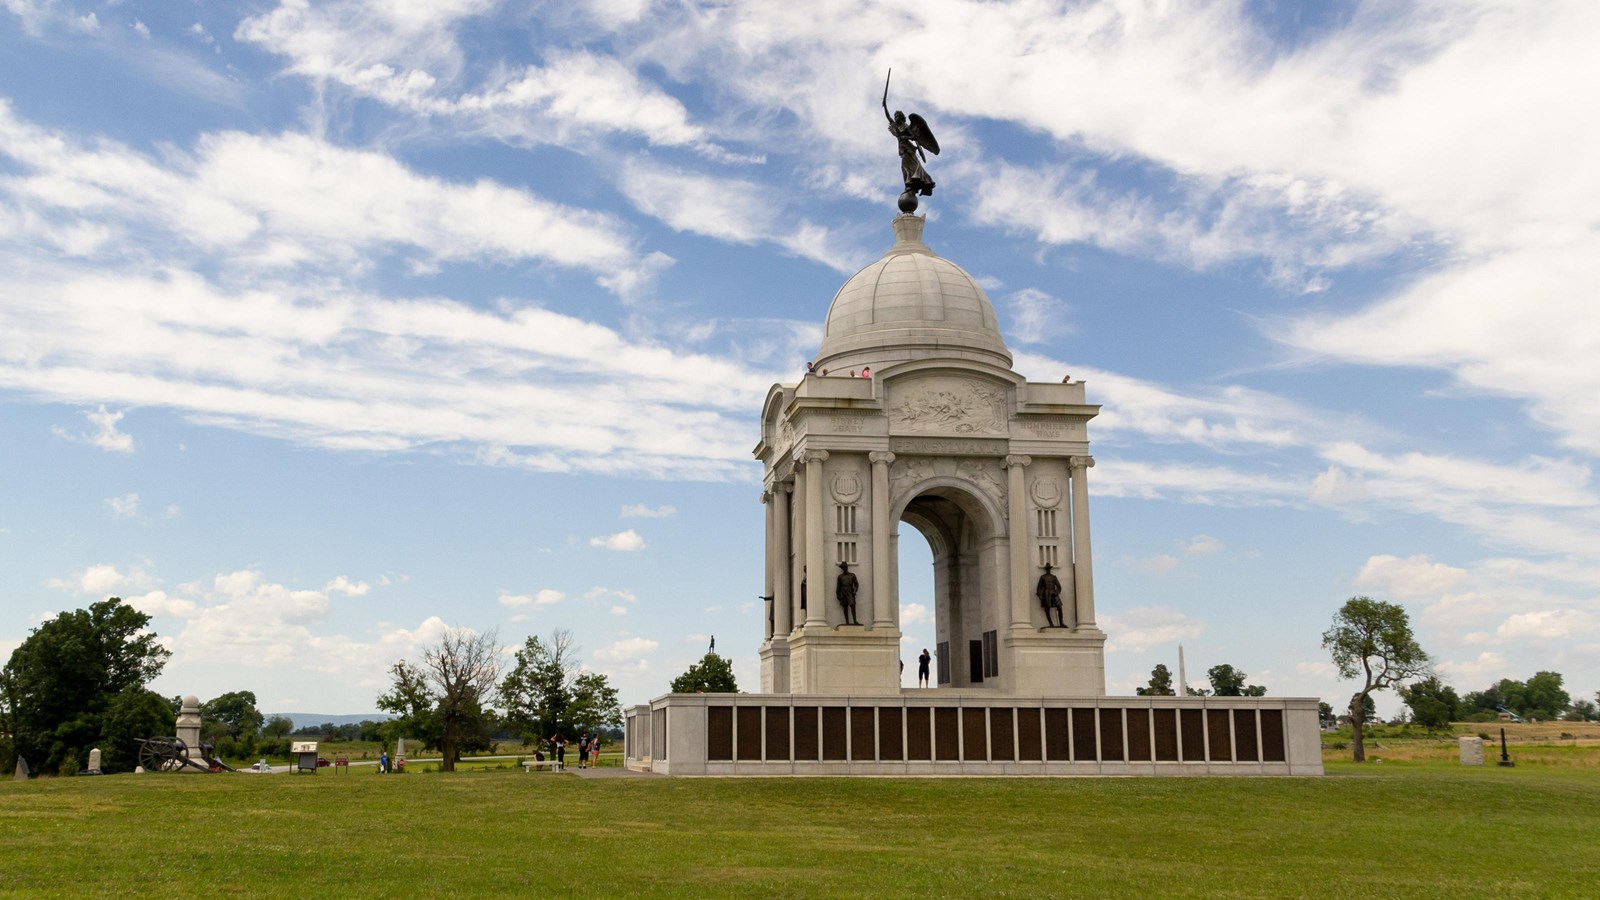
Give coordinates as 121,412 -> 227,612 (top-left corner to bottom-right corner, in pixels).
1322,597 -> 1430,762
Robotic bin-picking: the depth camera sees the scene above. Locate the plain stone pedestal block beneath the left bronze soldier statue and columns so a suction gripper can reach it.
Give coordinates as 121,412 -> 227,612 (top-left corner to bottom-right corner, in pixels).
789,625 -> 901,693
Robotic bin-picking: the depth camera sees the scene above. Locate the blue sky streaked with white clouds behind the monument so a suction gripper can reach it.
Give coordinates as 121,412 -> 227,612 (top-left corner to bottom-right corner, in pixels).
0,0 -> 1600,713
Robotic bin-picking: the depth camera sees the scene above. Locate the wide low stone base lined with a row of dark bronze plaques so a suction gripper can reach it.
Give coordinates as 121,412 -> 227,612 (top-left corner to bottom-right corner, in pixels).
624,689 -> 1323,777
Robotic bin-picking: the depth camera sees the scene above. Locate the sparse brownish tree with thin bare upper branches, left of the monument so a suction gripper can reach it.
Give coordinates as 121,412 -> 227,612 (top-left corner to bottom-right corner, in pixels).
378,628 -> 499,772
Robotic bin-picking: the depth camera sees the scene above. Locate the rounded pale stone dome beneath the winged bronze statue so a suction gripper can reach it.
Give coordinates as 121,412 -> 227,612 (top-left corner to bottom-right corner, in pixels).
816,215 -> 1011,372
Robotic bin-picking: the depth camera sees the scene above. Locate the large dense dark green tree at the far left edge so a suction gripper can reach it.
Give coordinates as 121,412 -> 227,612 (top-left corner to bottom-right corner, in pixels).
0,597 -> 171,772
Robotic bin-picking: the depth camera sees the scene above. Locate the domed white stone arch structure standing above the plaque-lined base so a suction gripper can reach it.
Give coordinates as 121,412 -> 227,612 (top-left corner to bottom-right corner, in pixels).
755,215 -> 1106,697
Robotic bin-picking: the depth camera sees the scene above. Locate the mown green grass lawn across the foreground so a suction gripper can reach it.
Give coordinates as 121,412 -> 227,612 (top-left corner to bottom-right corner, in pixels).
0,762 -> 1600,898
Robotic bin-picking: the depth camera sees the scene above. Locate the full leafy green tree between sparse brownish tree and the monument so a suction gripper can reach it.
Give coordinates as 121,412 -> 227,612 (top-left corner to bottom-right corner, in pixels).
499,629 -> 622,743
